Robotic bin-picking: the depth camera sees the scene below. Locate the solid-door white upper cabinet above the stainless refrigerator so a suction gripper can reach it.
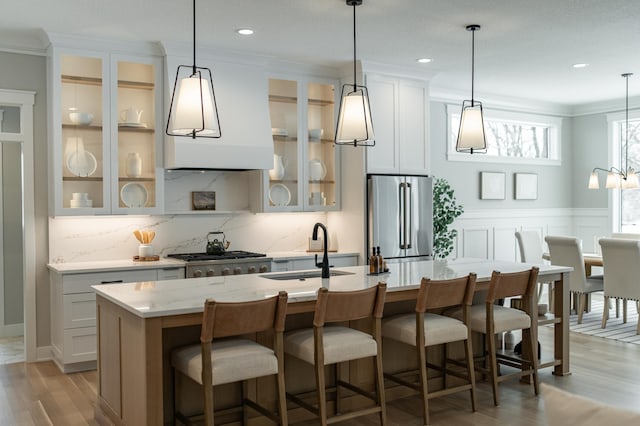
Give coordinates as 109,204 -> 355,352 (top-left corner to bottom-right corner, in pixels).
366,74 -> 430,175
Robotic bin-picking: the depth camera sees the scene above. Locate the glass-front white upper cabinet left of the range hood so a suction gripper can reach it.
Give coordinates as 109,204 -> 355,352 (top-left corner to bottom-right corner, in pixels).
47,38 -> 163,215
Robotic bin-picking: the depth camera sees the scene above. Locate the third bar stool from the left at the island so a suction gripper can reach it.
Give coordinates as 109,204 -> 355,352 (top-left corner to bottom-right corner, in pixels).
382,274 -> 477,425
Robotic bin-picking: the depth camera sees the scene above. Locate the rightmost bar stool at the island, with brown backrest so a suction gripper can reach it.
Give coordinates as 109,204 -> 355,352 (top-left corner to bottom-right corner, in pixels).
447,266 -> 539,405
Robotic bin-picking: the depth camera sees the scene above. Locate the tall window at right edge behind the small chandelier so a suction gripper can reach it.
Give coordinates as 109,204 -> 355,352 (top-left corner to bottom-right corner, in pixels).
610,114 -> 640,233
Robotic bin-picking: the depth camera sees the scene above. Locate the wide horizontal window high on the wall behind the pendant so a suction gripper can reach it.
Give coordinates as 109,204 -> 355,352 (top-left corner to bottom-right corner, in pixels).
447,105 -> 562,165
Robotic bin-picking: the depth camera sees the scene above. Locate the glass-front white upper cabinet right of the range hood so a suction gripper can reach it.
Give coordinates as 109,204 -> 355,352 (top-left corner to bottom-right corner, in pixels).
250,77 -> 340,212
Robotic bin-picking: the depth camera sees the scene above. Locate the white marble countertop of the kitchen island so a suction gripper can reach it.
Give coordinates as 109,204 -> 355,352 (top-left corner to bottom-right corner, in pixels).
92,259 -> 572,318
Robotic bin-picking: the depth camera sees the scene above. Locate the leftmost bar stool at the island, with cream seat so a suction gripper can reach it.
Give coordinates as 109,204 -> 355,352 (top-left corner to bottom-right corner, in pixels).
171,291 -> 287,426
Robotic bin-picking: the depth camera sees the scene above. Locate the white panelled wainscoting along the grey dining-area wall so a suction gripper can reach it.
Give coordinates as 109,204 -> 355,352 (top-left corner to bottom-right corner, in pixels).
452,209 -> 611,262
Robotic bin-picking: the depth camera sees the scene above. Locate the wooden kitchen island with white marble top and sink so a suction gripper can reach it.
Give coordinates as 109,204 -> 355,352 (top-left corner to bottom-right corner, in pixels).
94,259 -> 571,425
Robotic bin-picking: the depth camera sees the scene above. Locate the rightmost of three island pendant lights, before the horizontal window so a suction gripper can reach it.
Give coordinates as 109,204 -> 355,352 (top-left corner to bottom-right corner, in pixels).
456,24 -> 487,154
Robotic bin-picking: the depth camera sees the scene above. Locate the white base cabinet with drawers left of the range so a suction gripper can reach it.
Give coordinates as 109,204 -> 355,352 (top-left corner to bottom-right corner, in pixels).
49,267 -> 185,373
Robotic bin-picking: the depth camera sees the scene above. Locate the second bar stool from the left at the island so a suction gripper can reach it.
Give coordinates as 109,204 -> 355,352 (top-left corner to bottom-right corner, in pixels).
284,283 -> 387,426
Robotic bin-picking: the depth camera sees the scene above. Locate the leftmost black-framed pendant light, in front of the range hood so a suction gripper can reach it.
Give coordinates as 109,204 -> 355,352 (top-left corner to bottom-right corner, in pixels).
166,0 -> 222,139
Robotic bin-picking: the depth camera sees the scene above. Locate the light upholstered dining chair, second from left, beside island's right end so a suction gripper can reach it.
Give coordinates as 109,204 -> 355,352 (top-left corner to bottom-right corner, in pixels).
545,235 -> 604,324
